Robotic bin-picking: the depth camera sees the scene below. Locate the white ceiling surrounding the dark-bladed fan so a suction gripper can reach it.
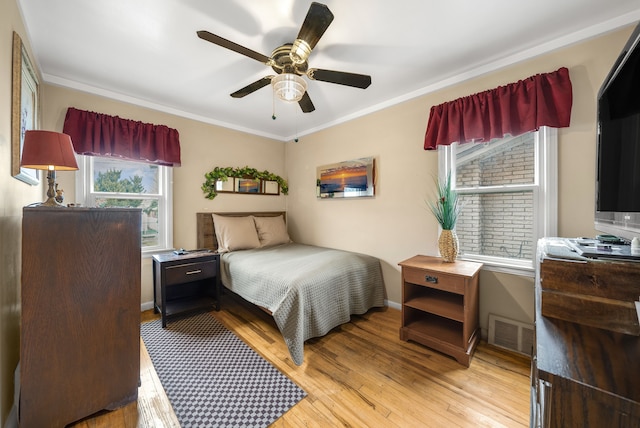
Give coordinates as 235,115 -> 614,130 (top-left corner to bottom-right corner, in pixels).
18,0 -> 640,141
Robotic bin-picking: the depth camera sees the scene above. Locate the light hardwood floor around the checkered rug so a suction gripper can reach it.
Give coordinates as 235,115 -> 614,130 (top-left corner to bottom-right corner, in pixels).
73,294 -> 530,428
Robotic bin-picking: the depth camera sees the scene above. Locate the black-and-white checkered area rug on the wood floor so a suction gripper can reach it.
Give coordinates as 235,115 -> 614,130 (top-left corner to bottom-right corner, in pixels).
140,313 -> 306,428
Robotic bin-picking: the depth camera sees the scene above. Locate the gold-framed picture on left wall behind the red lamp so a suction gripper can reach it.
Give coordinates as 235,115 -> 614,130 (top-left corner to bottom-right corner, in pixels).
11,31 -> 40,186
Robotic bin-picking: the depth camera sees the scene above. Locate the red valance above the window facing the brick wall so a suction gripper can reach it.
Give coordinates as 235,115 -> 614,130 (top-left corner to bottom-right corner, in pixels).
424,67 -> 573,150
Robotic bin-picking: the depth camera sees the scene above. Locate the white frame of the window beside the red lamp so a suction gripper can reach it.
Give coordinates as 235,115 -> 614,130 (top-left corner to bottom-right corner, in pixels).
76,155 -> 173,257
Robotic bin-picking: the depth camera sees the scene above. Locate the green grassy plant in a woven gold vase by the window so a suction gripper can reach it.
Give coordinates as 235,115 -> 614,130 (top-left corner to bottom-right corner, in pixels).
427,173 -> 461,262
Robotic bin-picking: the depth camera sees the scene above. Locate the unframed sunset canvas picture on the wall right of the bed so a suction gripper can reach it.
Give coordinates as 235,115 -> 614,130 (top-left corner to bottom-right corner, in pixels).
316,157 -> 375,199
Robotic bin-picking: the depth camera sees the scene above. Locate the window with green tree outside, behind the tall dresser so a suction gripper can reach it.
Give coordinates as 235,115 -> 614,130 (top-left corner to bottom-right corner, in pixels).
76,156 -> 173,253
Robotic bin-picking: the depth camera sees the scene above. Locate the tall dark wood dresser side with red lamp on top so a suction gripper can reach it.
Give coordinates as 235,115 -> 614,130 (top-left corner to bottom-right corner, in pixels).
18,207 -> 141,428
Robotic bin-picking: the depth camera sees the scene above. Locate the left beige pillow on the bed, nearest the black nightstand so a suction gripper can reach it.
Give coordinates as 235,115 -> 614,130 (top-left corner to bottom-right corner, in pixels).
211,214 -> 260,253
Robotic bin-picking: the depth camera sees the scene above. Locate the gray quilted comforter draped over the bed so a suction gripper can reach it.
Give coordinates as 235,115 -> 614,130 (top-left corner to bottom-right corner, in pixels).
221,244 -> 384,365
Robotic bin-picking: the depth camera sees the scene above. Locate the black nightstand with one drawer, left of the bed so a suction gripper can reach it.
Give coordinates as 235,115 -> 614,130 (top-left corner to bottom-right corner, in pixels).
153,251 -> 222,327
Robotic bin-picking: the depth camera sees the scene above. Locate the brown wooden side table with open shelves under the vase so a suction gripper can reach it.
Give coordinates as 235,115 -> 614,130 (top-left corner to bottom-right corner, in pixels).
398,255 -> 482,367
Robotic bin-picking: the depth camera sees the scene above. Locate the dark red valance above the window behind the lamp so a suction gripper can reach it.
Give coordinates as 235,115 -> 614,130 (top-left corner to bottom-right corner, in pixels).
62,107 -> 180,166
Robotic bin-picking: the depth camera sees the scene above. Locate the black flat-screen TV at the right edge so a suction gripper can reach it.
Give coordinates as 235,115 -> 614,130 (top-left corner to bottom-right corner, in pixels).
595,24 -> 640,240
